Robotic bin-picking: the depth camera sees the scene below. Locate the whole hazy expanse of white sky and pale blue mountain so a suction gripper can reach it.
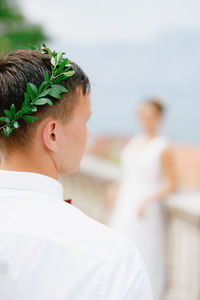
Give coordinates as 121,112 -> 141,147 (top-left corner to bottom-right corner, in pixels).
16,0 -> 200,142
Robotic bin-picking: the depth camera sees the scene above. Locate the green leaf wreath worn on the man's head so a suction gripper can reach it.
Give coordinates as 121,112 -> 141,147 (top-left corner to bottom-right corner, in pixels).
0,43 -> 75,136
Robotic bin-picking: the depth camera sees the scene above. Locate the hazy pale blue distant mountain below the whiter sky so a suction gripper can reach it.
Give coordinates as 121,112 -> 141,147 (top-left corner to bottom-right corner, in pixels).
49,32 -> 200,142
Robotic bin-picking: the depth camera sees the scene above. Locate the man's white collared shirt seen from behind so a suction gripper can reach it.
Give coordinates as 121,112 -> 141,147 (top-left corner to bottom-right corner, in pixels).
0,170 -> 152,300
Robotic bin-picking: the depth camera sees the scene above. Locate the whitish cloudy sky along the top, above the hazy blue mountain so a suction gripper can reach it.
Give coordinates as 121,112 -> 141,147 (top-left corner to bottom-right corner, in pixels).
18,0 -> 200,44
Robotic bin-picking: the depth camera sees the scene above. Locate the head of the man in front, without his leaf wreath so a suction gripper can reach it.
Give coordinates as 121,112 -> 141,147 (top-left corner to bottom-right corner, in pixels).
0,50 -> 91,174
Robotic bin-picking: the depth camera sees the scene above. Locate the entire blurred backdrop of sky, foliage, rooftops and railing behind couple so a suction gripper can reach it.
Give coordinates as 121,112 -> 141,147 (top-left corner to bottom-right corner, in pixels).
0,0 -> 200,300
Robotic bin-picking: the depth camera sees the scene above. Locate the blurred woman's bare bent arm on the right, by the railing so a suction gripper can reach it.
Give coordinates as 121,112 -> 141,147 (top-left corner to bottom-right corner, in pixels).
139,148 -> 177,217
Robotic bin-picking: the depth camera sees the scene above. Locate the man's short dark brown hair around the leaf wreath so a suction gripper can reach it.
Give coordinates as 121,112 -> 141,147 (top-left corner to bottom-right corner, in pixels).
0,50 -> 90,146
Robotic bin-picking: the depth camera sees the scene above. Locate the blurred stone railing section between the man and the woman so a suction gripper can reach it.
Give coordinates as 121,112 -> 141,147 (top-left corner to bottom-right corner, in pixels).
60,155 -> 120,224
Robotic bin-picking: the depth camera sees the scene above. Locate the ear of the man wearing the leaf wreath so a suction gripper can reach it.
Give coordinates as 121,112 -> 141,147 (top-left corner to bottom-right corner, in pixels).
42,120 -> 58,152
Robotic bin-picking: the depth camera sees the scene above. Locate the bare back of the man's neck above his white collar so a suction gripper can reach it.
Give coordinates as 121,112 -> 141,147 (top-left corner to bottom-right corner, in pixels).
0,149 -> 58,180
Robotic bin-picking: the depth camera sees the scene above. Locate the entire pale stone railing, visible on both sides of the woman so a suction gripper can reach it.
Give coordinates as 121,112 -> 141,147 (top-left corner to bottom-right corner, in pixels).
60,156 -> 200,300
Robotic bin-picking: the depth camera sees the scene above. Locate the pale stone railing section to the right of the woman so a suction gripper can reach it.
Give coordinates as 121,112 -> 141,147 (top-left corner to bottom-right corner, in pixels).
166,191 -> 200,300
